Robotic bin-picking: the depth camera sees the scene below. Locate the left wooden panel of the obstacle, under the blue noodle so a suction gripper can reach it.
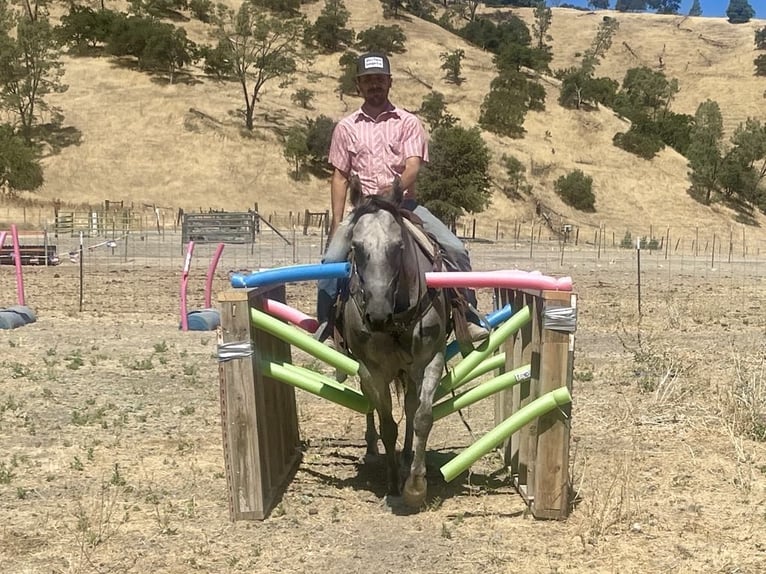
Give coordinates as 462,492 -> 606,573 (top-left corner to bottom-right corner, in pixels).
218,285 -> 301,520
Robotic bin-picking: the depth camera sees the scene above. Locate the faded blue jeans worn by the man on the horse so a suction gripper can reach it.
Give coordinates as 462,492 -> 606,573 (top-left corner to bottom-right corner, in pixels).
317,205 -> 476,323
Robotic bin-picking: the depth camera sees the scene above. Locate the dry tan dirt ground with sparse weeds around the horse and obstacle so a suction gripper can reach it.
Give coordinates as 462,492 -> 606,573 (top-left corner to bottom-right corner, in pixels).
0,245 -> 766,574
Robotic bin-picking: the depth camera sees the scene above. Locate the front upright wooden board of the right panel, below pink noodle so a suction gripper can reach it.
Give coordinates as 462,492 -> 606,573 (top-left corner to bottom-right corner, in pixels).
532,291 -> 576,519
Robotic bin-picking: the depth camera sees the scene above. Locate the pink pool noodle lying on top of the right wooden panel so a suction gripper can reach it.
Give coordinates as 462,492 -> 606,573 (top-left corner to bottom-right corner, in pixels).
426,271 -> 572,291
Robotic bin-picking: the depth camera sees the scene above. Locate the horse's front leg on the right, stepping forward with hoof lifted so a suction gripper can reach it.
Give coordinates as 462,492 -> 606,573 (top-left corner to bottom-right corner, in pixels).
404,353 -> 444,508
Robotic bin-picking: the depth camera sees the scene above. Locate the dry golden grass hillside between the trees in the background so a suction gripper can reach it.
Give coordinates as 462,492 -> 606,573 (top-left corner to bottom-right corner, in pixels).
10,0 -> 766,237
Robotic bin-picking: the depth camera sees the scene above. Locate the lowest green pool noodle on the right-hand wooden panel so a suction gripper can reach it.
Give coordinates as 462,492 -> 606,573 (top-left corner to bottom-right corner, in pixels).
439,387 -> 572,482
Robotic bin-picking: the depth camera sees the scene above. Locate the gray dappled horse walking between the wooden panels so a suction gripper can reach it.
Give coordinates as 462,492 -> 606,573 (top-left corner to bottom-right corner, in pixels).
336,179 -> 449,508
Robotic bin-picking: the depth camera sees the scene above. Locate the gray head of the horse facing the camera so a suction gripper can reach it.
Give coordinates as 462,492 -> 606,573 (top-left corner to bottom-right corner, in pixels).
350,180 -> 404,330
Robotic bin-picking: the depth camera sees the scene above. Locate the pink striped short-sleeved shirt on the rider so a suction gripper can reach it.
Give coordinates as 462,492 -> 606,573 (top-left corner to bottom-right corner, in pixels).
329,104 -> 428,196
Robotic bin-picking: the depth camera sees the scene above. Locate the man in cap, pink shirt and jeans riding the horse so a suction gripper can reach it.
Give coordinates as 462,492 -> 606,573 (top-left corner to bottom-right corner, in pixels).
317,53 -> 488,341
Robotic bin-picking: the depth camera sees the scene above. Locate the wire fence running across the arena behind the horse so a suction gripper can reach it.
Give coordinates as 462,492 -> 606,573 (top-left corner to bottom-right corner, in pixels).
0,222 -> 766,324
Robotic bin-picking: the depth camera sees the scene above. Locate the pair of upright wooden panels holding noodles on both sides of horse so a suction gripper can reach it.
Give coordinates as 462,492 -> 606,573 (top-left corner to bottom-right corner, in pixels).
219,285 -> 576,520
